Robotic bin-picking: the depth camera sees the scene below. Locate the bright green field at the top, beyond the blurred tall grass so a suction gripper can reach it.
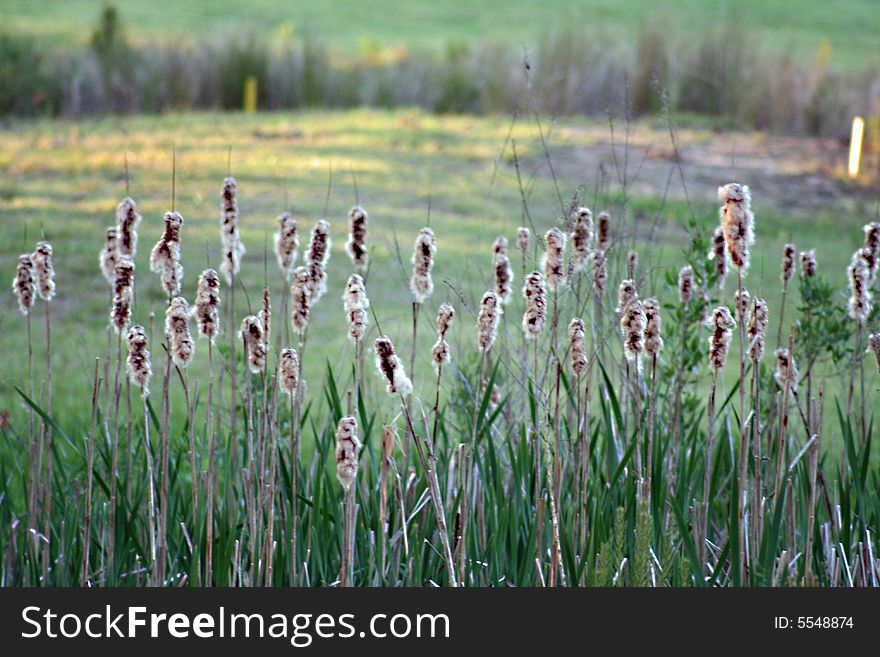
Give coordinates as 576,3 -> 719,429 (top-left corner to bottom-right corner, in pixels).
2,0 -> 880,67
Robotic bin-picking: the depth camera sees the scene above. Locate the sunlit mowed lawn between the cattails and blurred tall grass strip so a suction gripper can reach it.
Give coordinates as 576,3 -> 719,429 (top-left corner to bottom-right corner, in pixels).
0,110 -> 867,430
